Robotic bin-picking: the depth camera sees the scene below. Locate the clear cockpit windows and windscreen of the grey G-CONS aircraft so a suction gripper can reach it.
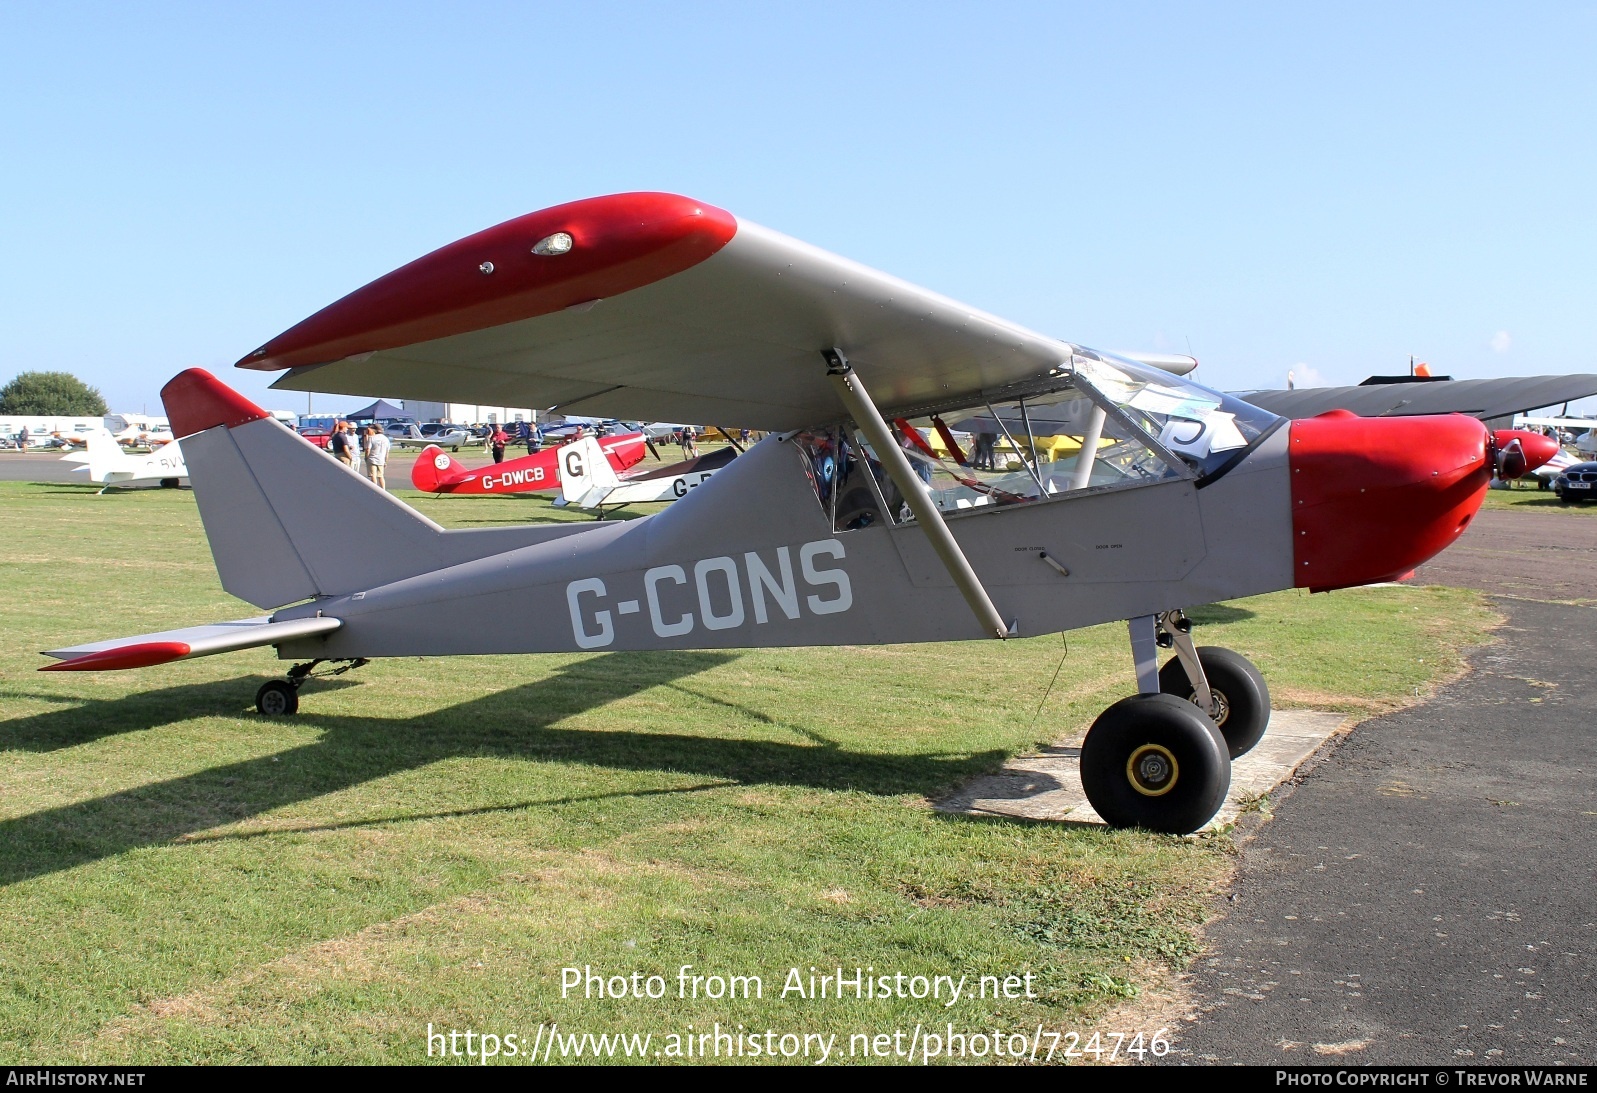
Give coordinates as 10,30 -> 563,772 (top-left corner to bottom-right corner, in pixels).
794,347 -> 1278,531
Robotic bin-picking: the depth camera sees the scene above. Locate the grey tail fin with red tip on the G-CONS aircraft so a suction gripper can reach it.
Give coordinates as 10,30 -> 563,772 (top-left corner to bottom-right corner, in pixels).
161,368 -> 536,607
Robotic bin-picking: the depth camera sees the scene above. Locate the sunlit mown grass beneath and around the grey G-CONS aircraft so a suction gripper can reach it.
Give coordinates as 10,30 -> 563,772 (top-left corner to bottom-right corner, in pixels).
0,475 -> 1493,1063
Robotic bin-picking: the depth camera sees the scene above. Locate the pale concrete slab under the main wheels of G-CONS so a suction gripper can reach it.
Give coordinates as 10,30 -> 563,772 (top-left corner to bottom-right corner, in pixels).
934,709 -> 1351,831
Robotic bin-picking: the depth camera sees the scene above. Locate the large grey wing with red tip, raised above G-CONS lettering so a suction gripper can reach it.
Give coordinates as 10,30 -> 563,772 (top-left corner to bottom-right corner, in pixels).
238,193 -> 1085,430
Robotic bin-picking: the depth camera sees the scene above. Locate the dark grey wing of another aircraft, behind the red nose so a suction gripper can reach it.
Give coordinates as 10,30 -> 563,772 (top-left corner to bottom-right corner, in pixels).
1236,376 -> 1597,419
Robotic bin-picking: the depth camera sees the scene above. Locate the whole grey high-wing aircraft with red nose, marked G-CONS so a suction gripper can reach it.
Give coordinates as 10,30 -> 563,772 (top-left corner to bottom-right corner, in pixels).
37,193 -> 1496,831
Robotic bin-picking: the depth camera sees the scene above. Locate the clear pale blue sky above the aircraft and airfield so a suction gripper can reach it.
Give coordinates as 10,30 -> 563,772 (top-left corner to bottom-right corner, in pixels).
0,0 -> 1597,411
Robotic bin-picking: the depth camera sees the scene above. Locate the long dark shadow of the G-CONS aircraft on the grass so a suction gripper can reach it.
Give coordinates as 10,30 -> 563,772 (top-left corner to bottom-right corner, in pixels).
0,652 -> 1003,885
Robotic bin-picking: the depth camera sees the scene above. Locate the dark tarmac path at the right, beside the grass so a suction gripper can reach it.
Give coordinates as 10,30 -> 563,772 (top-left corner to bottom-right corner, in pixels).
1164,511 -> 1597,1066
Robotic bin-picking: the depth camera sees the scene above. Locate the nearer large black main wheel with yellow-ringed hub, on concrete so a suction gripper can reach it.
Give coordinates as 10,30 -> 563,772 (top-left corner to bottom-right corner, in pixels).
1081,695 -> 1231,834
